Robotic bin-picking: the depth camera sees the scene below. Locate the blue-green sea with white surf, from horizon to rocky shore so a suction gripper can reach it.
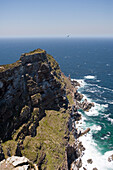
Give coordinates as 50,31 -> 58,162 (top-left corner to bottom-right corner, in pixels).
0,38 -> 113,170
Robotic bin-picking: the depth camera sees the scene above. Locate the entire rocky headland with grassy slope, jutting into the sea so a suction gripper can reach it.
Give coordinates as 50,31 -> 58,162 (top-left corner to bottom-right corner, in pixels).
0,49 -> 94,170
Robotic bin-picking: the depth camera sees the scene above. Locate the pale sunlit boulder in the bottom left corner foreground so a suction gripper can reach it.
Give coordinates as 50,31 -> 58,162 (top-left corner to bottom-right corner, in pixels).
0,156 -> 38,170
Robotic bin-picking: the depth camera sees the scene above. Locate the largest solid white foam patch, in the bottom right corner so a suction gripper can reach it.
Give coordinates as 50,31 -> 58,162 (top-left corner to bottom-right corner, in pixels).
80,134 -> 113,170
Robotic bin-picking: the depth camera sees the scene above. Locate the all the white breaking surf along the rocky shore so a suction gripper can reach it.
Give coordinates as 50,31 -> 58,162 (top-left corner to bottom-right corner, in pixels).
76,76 -> 113,170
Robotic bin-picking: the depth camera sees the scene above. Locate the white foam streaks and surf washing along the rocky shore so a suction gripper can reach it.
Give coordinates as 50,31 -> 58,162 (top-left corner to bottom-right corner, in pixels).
76,77 -> 113,170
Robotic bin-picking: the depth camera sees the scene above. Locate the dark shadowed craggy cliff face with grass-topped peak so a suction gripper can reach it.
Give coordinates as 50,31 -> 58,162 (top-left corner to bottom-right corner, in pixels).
0,49 -> 68,141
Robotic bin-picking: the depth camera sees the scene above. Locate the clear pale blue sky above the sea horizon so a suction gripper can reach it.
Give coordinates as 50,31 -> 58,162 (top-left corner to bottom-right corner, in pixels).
0,0 -> 113,37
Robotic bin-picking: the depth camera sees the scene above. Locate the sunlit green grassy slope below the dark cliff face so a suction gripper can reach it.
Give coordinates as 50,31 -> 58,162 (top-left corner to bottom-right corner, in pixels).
22,110 -> 69,170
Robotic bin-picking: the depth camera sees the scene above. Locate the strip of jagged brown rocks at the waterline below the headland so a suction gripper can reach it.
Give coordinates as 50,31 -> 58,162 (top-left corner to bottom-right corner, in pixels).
67,80 -> 97,170
